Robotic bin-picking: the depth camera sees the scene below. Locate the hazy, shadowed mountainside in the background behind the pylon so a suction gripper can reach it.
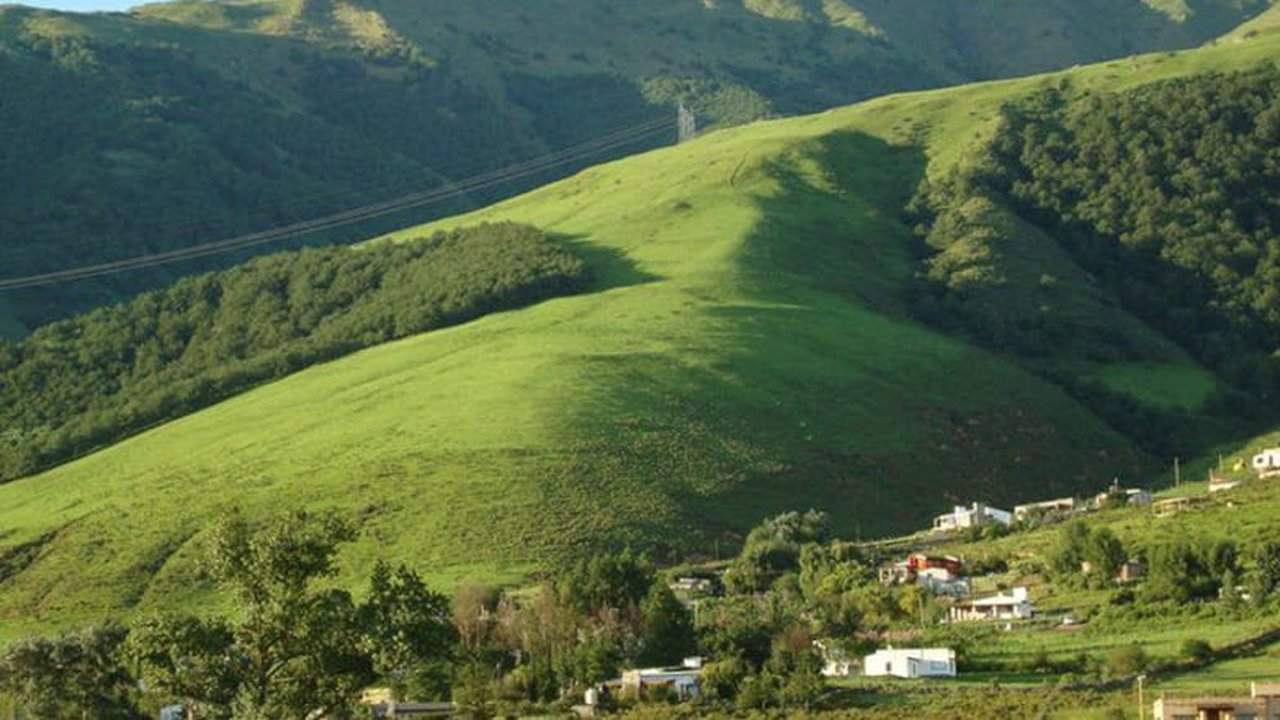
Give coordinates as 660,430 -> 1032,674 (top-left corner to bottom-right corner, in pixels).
0,0 -> 1266,337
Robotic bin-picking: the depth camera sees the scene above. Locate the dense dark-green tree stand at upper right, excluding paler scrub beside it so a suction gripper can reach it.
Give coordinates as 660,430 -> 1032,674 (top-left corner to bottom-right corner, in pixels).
996,67 -> 1280,368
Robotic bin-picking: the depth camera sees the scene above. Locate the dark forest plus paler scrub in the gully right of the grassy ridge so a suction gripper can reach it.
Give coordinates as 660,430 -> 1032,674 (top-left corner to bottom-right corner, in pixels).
915,65 -> 1280,452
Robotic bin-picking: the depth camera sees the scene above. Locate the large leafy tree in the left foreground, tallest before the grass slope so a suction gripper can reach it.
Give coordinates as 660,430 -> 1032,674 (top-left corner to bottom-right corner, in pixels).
129,512 -> 454,720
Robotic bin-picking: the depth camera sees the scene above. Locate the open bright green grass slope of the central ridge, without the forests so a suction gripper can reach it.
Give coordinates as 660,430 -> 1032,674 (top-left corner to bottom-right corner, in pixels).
0,29 -> 1277,637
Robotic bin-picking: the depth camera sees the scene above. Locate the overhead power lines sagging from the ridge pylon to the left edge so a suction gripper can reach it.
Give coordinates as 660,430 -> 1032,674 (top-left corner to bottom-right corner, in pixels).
0,117 -> 671,291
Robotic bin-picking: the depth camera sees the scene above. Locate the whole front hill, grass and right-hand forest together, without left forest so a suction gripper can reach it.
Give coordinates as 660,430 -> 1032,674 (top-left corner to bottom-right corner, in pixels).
0,36 -> 1280,624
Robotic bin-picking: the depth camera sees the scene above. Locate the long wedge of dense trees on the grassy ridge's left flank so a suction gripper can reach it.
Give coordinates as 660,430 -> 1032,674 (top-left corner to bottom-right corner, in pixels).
0,223 -> 588,479
